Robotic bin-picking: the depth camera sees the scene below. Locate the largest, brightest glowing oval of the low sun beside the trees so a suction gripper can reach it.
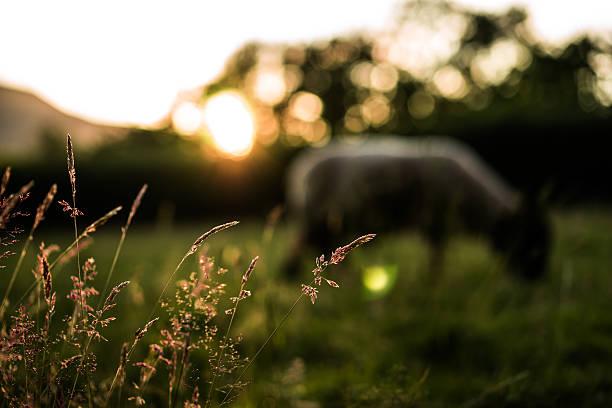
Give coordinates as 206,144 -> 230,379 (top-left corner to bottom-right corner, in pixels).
204,91 -> 255,157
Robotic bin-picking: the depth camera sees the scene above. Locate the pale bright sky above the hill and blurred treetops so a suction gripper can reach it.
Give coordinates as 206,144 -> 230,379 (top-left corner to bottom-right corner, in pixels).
0,0 -> 612,125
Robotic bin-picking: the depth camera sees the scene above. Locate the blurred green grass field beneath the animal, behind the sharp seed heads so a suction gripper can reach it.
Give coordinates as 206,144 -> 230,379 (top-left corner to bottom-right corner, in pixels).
2,208 -> 612,407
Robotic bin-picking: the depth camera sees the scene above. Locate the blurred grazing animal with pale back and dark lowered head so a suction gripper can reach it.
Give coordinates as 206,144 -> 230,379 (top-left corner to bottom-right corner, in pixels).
287,137 -> 550,278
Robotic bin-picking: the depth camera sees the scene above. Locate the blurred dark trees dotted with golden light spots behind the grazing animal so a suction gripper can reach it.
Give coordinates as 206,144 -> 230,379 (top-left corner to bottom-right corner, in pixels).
203,1 -> 612,201
